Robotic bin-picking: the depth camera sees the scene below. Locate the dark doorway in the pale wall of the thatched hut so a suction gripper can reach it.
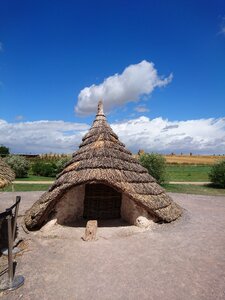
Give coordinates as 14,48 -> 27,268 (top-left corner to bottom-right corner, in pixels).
83,184 -> 121,219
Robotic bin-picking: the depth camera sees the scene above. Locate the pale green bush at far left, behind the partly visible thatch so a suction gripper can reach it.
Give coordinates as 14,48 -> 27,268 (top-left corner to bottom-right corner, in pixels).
5,155 -> 30,178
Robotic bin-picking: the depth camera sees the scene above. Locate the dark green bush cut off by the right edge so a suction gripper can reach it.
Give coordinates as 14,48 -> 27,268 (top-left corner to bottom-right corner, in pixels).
209,159 -> 225,188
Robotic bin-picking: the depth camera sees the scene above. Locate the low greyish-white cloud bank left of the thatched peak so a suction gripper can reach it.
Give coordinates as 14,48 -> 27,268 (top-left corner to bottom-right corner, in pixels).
0,120 -> 89,153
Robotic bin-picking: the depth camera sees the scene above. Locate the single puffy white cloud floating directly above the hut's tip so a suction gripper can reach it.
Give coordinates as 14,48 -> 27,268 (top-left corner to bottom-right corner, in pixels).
75,60 -> 172,115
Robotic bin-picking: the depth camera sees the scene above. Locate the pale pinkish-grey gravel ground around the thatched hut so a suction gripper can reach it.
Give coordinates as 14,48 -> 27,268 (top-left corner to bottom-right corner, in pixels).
0,192 -> 225,300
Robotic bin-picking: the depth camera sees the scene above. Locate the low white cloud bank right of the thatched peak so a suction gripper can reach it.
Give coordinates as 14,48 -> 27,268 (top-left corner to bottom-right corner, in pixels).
112,117 -> 225,154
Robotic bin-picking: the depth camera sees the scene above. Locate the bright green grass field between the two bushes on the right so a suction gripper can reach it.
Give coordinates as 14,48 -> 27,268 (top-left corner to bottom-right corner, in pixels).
166,165 -> 211,181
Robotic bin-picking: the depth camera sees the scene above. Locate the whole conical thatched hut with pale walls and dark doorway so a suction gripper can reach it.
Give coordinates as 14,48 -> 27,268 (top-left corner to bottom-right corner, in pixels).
25,101 -> 182,230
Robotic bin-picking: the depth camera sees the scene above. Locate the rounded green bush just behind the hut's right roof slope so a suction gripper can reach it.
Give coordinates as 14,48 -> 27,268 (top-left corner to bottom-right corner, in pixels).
139,153 -> 166,183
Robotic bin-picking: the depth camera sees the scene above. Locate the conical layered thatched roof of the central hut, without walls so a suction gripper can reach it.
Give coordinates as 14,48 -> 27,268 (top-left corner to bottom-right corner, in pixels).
25,102 -> 181,229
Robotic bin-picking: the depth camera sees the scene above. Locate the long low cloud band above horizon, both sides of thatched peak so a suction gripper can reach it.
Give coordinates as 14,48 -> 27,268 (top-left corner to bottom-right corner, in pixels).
0,116 -> 225,154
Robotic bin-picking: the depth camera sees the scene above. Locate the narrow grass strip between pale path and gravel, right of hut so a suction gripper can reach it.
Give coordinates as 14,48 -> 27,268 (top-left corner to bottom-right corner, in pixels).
162,184 -> 225,196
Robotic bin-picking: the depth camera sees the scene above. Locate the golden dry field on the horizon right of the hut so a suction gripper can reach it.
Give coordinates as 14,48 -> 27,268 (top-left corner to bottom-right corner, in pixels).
164,155 -> 225,165
